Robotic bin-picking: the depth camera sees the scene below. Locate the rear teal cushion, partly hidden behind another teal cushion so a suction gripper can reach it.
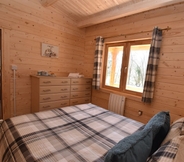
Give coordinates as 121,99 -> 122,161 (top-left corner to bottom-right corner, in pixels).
144,111 -> 170,155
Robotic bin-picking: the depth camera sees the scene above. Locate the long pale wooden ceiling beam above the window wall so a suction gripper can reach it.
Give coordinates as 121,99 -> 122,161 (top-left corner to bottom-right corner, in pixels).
78,0 -> 184,28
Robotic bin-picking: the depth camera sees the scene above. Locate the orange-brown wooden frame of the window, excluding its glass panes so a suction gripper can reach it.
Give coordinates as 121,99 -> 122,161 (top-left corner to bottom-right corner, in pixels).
102,39 -> 151,96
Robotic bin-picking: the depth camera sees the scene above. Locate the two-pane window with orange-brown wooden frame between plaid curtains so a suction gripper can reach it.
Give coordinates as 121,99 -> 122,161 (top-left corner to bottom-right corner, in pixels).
102,40 -> 150,95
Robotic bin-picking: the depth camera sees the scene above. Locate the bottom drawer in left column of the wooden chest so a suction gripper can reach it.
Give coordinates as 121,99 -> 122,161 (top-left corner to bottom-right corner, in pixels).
40,100 -> 69,111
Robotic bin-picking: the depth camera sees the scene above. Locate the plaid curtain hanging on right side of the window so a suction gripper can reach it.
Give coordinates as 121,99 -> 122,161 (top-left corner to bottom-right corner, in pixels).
142,27 -> 162,103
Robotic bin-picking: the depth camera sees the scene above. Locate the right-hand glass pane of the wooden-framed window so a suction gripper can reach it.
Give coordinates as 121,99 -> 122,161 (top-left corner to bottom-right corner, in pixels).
126,44 -> 150,93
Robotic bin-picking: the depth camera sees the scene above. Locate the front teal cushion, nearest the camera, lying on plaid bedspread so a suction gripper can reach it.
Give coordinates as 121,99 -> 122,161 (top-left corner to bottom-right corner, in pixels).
105,128 -> 153,162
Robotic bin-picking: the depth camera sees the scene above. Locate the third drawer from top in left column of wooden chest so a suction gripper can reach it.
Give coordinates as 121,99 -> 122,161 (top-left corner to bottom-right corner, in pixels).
40,92 -> 70,102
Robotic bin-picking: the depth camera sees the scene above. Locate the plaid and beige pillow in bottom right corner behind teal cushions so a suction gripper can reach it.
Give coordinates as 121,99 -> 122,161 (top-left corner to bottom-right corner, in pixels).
148,118 -> 184,162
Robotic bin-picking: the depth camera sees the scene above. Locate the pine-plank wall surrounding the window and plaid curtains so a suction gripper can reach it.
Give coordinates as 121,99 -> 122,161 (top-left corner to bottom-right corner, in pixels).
84,3 -> 184,123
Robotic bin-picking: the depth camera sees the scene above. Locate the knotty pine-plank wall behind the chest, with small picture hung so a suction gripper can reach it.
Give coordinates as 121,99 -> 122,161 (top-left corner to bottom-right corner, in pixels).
0,0 -> 85,118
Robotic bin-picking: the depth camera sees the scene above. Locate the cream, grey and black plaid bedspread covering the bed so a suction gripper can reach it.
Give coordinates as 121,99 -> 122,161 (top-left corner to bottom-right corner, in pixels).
0,104 -> 143,162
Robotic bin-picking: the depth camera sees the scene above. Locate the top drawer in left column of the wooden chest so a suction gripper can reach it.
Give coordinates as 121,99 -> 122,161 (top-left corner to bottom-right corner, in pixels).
40,78 -> 70,85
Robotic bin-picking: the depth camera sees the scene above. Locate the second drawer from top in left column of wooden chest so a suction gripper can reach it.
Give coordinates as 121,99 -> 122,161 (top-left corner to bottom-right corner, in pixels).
40,86 -> 70,94
